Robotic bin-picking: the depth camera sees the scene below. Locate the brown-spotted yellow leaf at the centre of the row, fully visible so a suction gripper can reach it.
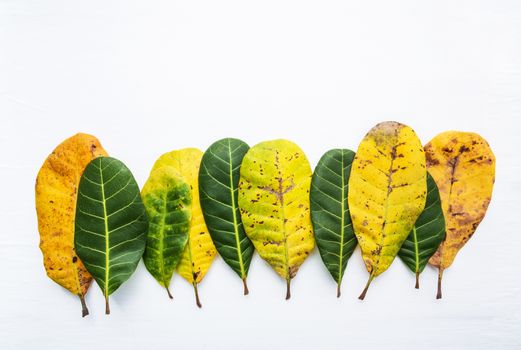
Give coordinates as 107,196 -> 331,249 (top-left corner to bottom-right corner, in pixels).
239,140 -> 315,299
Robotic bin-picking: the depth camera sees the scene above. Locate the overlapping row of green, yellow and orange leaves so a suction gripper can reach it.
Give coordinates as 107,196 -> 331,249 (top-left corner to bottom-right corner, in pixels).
36,122 -> 495,316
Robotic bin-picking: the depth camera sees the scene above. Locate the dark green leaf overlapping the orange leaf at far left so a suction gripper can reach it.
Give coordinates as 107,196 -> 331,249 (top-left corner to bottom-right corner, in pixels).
74,157 -> 148,314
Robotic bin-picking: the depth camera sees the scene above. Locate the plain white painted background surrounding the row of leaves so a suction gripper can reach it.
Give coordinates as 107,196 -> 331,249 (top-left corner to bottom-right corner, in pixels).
0,0 -> 521,350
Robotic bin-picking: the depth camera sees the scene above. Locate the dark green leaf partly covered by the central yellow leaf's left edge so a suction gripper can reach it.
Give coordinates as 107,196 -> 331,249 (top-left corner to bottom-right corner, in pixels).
199,138 -> 253,295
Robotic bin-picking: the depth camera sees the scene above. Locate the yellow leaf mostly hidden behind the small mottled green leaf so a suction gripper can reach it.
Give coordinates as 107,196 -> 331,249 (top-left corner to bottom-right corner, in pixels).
152,148 -> 217,307
